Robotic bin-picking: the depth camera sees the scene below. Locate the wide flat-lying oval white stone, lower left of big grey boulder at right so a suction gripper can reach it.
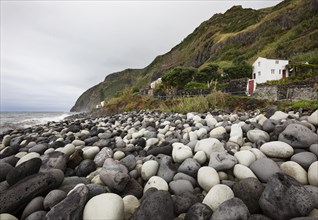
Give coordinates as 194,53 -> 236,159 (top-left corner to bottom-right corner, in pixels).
260,141 -> 294,158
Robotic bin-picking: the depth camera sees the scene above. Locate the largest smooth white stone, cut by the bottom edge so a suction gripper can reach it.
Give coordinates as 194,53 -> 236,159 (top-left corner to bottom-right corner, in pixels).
83,193 -> 124,220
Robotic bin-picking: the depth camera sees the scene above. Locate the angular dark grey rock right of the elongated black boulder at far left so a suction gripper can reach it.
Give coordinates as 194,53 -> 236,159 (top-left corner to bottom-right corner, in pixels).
40,151 -> 68,172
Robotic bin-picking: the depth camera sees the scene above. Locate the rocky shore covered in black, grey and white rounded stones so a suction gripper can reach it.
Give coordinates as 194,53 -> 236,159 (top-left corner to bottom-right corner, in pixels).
0,110 -> 318,220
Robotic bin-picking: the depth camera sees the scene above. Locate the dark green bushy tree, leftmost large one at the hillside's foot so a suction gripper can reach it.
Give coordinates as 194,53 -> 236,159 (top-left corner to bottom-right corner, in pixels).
161,67 -> 197,89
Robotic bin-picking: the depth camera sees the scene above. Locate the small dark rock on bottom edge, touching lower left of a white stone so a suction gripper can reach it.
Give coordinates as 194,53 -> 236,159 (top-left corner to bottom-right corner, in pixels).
184,203 -> 213,220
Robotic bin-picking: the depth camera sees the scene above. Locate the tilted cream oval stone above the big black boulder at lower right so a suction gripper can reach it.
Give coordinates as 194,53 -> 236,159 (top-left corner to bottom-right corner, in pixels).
280,161 -> 308,185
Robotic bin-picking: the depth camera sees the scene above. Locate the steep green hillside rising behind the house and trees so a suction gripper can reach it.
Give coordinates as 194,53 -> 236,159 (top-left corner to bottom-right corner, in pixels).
71,0 -> 318,111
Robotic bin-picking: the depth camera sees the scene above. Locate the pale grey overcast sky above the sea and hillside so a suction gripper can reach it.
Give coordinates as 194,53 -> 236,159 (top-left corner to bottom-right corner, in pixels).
0,0 -> 280,111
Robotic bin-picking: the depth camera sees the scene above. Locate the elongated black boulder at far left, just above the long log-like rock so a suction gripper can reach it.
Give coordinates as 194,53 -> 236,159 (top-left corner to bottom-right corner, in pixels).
6,158 -> 42,186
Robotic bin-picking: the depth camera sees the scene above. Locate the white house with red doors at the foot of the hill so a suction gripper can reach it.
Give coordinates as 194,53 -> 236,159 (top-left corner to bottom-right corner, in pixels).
248,57 -> 288,94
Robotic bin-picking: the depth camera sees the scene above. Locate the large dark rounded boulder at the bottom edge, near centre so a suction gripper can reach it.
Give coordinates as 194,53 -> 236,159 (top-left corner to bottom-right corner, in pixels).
132,190 -> 175,220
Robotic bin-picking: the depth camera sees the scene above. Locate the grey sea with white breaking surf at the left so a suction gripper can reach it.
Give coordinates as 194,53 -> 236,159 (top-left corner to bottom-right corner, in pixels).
0,112 -> 75,134
